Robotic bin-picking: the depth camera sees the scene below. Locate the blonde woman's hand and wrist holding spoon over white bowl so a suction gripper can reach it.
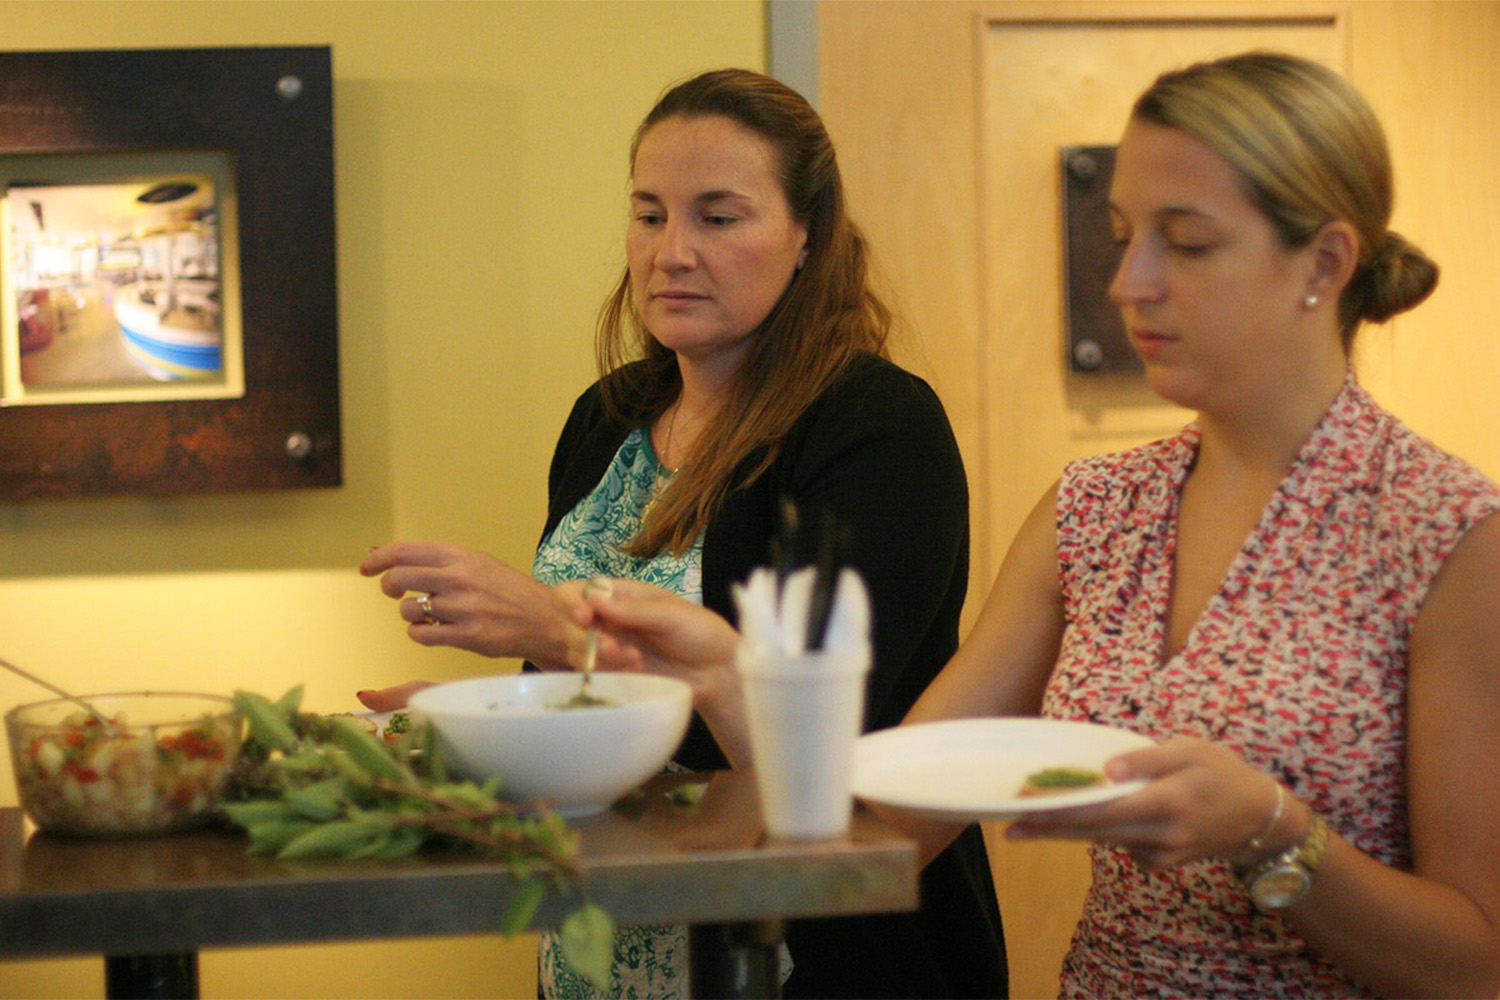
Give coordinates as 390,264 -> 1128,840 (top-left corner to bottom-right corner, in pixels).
557,580 -> 750,768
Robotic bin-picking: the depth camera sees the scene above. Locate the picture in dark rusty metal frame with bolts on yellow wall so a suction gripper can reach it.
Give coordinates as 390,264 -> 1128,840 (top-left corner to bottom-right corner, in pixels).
0,46 -> 342,501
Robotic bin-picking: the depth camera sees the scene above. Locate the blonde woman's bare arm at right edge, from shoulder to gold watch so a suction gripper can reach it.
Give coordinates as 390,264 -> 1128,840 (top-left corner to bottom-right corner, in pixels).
1320,517 -> 1500,1000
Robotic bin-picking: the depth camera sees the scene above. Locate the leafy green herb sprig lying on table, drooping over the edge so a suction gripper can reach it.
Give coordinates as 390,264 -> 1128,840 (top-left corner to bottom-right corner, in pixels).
224,687 -> 615,988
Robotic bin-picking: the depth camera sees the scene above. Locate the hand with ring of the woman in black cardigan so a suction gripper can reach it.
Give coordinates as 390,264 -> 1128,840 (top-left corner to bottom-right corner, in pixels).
360,541 -> 581,670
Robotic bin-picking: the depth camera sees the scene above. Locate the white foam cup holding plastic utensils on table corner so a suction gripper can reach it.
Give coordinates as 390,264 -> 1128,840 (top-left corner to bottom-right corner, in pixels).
735,643 -> 870,840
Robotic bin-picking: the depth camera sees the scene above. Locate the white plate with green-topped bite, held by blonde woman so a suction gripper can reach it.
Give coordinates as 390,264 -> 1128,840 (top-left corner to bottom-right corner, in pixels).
854,718 -> 1152,822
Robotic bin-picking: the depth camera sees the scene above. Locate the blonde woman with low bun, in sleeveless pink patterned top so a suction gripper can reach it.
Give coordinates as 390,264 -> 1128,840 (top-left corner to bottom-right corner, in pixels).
575,52 -> 1500,997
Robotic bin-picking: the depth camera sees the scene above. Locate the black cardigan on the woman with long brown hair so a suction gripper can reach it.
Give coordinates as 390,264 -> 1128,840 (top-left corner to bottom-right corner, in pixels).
543,354 -> 1007,997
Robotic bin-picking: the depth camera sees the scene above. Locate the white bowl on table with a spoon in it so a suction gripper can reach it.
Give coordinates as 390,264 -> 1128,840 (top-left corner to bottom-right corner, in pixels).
410,673 -> 693,817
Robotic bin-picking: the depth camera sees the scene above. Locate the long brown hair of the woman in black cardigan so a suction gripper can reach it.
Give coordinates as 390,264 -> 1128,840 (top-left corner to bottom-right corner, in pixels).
596,69 -> 891,556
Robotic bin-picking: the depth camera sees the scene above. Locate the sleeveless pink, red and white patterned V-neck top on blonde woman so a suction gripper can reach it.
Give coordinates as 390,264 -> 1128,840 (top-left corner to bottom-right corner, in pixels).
1043,376 -> 1500,997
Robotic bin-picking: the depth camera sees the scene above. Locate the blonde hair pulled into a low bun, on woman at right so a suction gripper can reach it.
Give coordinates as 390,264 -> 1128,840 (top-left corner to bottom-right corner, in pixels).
1131,52 -> 1439,351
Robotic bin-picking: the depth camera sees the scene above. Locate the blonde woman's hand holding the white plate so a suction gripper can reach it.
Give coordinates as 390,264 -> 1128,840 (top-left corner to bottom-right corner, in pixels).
1007,738 -> 1284,868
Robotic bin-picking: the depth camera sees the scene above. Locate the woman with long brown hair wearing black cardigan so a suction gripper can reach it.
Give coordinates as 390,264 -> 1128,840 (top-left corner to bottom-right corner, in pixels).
362,69 -> 1007,997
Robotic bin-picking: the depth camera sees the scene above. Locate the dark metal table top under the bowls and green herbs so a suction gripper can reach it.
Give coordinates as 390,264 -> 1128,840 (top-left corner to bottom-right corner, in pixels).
0,771 -> 917,958
